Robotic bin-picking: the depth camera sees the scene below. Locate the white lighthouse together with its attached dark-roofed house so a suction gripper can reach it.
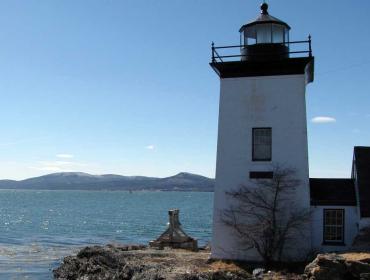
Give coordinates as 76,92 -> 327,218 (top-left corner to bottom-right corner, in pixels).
210,3 -> 370,261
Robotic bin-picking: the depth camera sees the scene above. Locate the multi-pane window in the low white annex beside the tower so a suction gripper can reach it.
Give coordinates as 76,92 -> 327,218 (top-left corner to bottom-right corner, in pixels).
324,209 -> 344,244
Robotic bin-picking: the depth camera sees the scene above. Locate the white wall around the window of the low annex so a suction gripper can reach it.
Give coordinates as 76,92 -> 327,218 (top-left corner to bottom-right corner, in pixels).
311,206 -> 359,252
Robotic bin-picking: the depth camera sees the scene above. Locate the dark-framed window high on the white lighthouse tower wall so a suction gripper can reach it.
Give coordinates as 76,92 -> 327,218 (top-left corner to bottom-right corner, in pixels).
252,128 -> 272,161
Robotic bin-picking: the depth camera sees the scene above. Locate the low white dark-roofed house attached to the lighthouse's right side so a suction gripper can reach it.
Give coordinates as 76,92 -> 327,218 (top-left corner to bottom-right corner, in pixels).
310,147 -> 370,251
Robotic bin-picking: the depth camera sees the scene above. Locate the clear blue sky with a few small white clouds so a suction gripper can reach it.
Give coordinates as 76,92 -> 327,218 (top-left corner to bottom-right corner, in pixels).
0,0 -> 370,180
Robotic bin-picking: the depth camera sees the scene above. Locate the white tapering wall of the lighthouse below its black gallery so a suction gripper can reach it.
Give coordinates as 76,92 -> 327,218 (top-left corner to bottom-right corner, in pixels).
211,75 -> 311,260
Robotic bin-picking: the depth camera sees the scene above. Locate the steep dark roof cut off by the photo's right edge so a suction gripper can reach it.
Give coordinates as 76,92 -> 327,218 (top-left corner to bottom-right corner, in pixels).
352,147 -> 370,217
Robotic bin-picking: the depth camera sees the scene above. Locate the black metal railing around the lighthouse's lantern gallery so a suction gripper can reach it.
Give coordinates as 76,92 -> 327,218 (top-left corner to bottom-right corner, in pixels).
212,35 -> 312,62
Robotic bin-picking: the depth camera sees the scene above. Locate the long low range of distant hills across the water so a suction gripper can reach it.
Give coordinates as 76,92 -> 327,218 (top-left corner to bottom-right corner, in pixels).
0,172 -> 214,192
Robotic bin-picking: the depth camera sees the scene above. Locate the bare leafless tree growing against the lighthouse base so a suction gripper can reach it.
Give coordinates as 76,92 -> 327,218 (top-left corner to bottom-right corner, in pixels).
220,166 -> 310,264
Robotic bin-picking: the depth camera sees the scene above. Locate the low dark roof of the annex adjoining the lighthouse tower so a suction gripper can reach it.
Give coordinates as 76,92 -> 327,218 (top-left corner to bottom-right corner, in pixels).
310,178 -> 356,206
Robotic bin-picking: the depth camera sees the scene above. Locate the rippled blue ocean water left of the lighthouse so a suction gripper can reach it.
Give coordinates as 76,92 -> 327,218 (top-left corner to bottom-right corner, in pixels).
0,190 -> 213,280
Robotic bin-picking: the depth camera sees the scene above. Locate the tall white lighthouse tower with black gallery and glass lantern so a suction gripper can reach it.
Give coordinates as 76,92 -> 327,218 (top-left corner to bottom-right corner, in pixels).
210,3 -> 314,260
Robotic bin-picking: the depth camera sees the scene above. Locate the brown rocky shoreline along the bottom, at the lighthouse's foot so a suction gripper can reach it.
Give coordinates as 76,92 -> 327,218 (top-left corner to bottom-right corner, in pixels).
53,244 -> 370,280
